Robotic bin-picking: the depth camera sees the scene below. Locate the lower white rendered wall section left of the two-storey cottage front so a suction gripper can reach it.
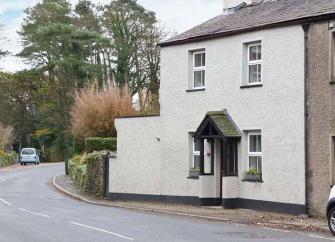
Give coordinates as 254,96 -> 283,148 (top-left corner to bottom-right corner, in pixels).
109,117 -> 161,194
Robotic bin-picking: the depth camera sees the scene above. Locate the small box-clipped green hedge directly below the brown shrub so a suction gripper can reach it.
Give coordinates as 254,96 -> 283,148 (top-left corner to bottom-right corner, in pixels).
85,138 -> 117,153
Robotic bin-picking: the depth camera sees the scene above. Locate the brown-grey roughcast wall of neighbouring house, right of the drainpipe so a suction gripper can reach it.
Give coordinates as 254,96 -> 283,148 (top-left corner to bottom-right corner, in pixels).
308,21 -> 335,216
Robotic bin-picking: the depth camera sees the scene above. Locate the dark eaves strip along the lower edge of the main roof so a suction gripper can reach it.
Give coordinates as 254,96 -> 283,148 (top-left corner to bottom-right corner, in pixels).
158,13 -> 335,47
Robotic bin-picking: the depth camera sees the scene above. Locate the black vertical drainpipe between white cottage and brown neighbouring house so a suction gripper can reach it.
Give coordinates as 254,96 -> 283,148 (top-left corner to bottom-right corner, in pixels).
302,23 -> 310,214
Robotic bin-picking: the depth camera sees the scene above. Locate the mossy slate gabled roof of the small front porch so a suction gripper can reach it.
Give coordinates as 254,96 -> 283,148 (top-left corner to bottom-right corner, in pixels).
194,110 -> 242,138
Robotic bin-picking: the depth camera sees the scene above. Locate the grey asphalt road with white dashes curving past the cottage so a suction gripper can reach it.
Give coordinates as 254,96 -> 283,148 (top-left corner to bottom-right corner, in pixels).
0,164 -> 335,242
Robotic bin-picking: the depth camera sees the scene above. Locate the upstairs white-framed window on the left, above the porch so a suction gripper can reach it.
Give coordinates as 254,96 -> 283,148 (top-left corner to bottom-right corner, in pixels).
193,51 -> 206,89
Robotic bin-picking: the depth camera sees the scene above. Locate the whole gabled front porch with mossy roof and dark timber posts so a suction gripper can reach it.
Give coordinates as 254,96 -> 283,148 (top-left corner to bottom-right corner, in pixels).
194,110 -> 242,206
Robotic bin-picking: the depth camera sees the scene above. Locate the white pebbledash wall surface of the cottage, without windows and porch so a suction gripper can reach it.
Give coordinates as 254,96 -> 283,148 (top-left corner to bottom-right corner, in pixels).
109,25 -> 305,213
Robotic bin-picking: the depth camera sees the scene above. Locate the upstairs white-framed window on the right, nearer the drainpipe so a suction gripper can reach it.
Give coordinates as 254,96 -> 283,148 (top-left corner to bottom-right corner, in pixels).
247,42 -> 262,85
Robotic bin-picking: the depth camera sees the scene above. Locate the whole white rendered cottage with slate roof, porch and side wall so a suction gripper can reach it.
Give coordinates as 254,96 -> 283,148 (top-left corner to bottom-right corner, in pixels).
109,0 -> 335,214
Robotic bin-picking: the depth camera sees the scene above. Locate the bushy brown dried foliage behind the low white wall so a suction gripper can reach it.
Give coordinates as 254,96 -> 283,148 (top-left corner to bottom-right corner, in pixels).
71,86 -> 137,142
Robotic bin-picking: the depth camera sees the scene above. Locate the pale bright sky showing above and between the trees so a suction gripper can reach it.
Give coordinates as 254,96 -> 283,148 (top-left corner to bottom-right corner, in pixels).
0,0 -> 223,72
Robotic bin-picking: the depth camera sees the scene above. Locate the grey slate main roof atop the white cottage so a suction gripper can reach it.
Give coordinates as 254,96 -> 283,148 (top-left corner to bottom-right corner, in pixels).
160,0 -> 335,46
